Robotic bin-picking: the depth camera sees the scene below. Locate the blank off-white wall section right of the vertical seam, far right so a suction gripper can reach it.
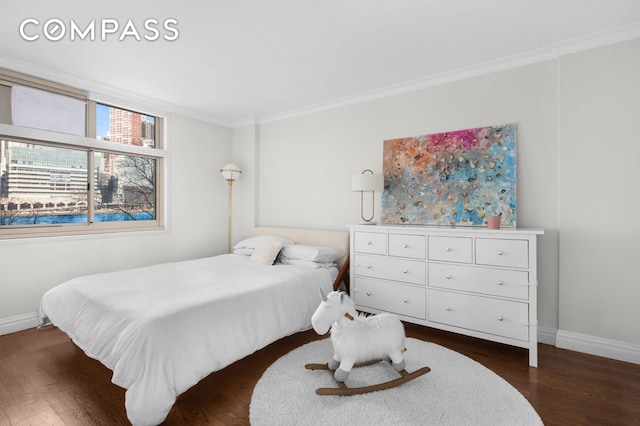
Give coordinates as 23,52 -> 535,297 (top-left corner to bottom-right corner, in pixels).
559,39 -> 640,350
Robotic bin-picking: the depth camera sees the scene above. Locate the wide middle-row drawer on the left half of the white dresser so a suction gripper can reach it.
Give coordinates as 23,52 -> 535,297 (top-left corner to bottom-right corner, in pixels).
354,254 -> 427,285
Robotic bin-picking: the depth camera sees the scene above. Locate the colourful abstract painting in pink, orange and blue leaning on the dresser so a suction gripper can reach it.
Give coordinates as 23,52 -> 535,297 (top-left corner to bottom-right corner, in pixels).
381,123 -> 516,227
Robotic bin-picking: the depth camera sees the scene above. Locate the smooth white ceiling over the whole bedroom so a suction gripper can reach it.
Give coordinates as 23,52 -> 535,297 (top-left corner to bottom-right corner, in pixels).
0,0 -> 640,126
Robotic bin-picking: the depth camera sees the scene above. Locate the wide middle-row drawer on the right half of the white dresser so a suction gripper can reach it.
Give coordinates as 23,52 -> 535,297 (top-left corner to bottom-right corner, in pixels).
429,263 -> 529,300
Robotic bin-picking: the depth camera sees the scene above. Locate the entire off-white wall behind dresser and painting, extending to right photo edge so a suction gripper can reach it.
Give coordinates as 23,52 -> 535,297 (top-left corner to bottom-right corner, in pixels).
245,39 -> 640,363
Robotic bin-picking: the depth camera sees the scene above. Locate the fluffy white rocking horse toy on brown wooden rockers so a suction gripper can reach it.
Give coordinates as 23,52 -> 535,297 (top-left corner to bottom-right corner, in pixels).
305,289 -> 431,395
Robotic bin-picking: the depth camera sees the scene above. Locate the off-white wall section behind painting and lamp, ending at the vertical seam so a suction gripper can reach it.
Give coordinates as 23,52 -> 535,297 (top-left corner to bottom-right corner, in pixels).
252,61 -> 558,329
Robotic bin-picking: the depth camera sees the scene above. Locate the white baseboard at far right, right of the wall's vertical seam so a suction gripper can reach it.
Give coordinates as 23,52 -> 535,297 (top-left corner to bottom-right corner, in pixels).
556,330 -> 640,364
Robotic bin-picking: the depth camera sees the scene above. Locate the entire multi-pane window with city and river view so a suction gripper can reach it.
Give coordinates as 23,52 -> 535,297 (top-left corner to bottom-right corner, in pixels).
0,70 -> 166,239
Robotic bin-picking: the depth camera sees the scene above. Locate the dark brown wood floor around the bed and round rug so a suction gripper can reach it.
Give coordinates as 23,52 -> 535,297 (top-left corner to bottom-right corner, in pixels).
0,324 -> 640,426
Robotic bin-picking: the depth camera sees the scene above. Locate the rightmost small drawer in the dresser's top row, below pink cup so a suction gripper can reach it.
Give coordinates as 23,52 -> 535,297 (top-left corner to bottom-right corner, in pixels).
476,238 -> 529,268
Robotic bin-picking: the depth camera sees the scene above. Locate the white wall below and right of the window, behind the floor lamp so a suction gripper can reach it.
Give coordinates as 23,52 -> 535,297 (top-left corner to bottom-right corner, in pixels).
0,111 -> 232,334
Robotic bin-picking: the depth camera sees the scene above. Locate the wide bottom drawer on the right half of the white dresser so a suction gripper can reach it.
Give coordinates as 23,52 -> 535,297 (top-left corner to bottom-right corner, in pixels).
428,289 -> 529,342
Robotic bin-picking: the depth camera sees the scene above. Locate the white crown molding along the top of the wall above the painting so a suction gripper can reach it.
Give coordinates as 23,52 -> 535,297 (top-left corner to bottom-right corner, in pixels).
248,23 -> 640,127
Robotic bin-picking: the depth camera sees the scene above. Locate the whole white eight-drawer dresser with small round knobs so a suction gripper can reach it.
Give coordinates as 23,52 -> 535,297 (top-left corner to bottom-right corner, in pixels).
349,225 -> 543,367
